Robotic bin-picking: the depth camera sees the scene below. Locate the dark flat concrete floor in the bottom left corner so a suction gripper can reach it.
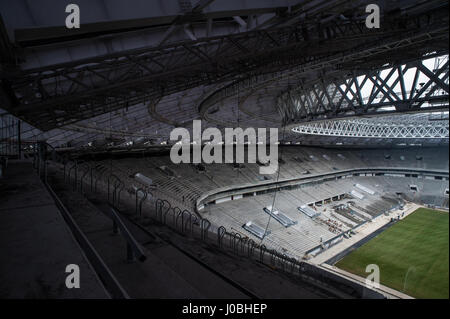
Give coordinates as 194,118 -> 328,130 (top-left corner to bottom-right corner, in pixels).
0,161 -> 109,298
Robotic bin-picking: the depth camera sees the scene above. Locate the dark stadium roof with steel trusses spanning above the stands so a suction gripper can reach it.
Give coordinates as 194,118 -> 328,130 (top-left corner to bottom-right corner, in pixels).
0,0 -> 449,146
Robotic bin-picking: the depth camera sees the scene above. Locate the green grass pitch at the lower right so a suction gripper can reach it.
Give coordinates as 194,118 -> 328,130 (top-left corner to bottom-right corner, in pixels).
335,208 -> 449,298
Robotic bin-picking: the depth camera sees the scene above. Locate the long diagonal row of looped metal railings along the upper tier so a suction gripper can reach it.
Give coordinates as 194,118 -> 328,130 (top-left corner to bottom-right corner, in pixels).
34,142 -> 379,297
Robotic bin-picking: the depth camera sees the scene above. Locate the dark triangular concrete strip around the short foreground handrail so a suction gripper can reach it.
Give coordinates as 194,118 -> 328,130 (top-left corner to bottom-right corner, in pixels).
50,178 -> 248,299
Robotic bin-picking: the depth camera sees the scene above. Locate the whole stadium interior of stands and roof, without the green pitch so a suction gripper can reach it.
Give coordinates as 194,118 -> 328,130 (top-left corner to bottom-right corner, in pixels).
0,0 -> 449,299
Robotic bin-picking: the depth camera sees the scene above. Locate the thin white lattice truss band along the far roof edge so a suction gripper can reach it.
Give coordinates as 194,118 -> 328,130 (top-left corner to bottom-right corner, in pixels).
292,117 -> 449,139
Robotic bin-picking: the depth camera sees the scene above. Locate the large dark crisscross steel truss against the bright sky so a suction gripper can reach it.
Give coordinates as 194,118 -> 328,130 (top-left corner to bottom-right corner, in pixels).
277,55 -> 449,123
